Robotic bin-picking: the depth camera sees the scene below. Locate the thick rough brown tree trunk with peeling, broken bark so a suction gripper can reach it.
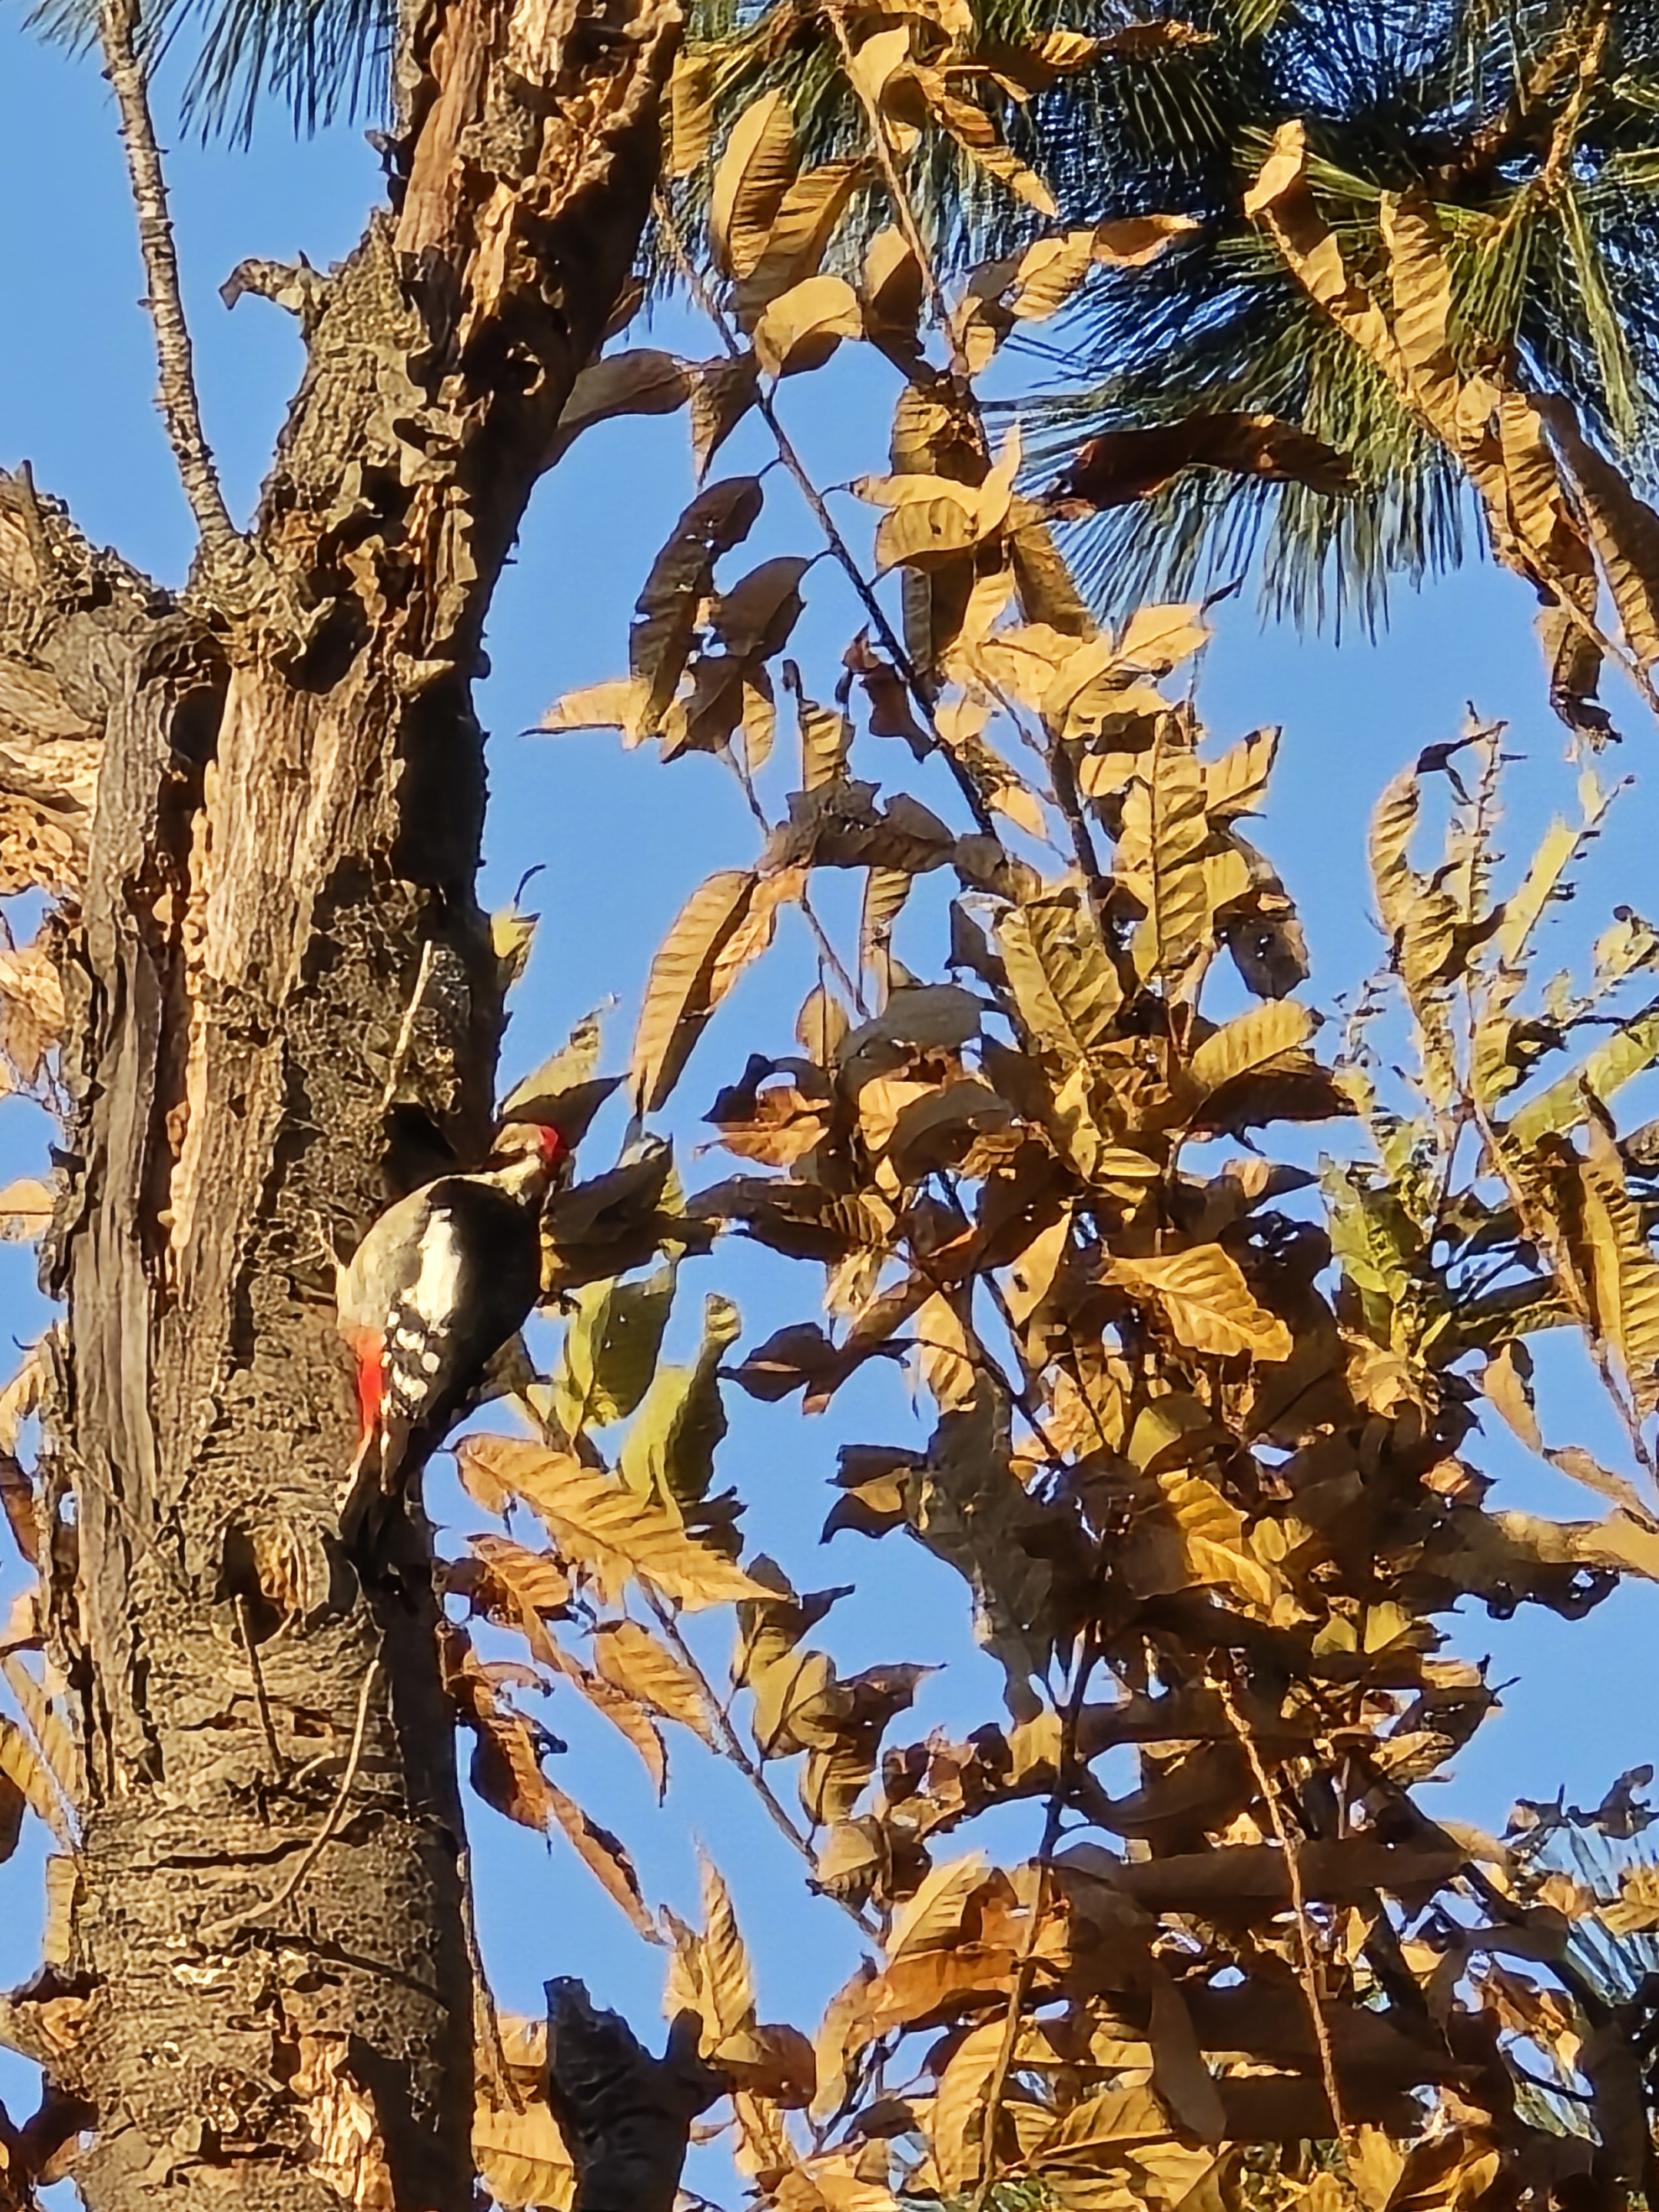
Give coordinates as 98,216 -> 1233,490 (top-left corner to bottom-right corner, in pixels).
0,0 -> 679,2212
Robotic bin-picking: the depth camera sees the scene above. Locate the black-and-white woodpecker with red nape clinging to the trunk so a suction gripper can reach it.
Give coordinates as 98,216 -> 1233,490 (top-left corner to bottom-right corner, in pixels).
336,1121 -> 568,1524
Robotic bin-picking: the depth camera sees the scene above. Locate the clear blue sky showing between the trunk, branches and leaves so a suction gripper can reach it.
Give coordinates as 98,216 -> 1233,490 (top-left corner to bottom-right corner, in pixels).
0,9 -> 1657,2194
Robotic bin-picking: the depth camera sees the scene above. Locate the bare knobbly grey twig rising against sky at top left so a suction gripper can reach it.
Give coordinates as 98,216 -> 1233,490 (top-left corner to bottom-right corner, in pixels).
100,0 -> 243,557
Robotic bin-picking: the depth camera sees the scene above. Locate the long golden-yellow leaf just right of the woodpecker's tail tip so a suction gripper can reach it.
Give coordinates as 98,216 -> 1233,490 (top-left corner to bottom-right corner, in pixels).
456,1436 -> 768,1613
